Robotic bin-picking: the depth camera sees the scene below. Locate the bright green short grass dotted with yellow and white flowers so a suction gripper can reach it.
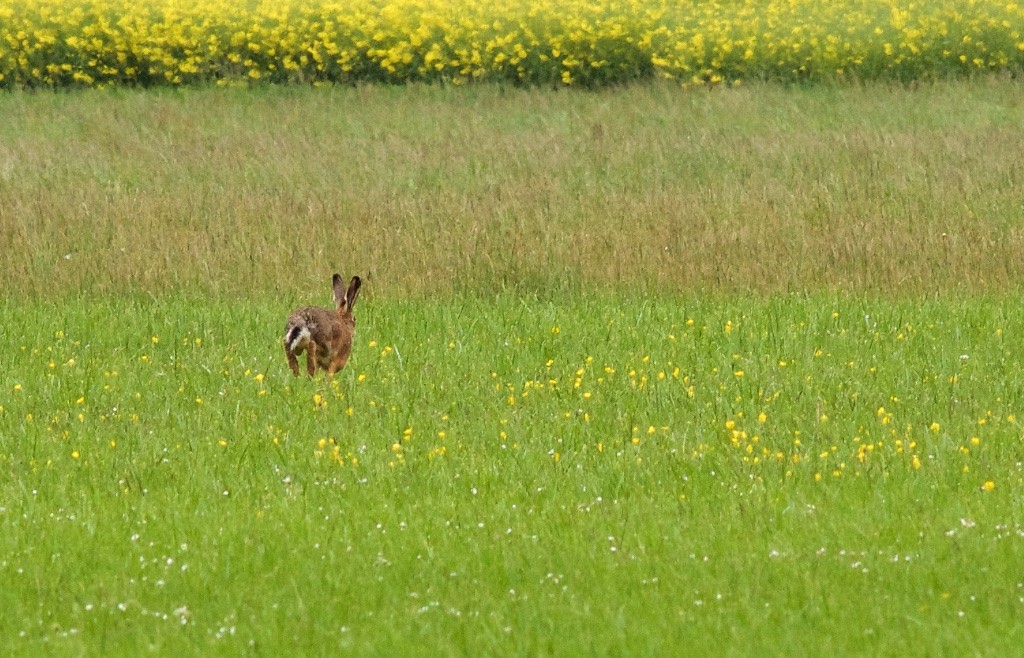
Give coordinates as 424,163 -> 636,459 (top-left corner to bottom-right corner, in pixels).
0,295 -> 1024,655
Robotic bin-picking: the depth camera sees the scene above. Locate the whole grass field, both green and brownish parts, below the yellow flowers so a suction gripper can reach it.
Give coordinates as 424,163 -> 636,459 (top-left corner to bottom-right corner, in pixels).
0,80 -> 1024,655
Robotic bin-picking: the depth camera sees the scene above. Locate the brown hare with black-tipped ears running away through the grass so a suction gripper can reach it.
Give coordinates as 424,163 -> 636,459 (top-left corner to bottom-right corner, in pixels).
285,274 -> 362,377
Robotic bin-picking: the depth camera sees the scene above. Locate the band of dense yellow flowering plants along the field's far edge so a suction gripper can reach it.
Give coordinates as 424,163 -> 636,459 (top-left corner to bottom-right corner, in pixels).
0,0 -> 1024,88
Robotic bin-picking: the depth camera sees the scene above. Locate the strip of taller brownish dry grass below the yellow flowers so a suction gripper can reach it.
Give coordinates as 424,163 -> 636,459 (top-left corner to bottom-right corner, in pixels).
0,80 -> 1024,297
